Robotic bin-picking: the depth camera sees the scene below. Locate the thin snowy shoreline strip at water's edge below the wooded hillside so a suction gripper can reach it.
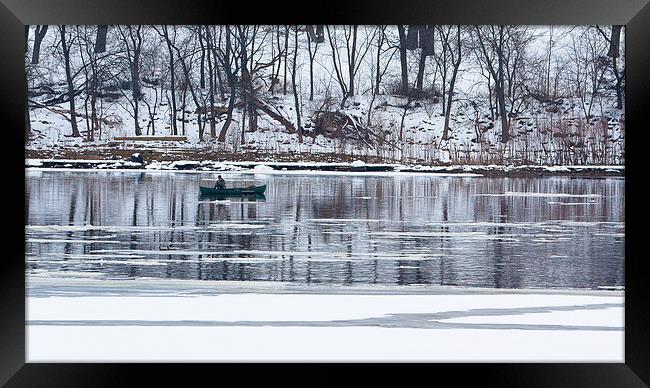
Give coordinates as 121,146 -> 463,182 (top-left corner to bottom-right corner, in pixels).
25,159 -> 625,176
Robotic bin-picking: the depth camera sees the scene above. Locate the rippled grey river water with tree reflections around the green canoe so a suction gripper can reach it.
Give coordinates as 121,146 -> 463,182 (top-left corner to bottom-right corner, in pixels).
25,170 -> 625,288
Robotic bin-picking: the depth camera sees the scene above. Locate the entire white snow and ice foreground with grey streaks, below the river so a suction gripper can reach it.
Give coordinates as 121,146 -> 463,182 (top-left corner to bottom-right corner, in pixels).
26,276 -> 624,362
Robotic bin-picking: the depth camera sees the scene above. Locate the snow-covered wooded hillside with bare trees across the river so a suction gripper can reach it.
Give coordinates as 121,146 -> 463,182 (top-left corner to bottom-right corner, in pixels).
25,25 -> 626,165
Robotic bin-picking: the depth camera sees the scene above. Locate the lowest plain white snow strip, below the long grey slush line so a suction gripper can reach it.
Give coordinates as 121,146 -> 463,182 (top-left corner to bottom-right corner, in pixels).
27,326 -> 623,362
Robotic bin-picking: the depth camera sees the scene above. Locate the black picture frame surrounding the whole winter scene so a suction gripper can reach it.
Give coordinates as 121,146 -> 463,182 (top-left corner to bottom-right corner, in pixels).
0,0 -> 650,387
